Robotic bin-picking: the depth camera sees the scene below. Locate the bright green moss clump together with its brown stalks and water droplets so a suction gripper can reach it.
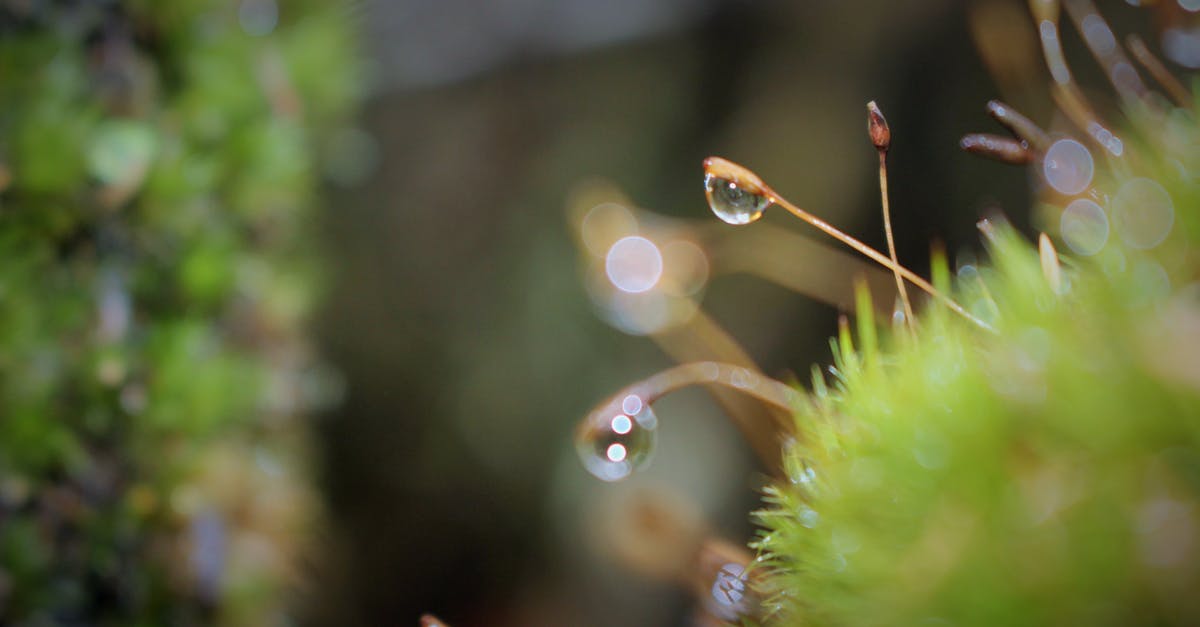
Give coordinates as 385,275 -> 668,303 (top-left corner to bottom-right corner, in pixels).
575,0 -> 1200,626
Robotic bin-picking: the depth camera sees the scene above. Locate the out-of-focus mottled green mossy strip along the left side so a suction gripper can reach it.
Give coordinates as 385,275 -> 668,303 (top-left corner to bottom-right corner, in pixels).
0,0 -> 361,625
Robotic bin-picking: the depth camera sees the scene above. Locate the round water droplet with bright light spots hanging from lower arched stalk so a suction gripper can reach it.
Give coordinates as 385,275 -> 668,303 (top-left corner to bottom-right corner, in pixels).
575,395 -> 659,482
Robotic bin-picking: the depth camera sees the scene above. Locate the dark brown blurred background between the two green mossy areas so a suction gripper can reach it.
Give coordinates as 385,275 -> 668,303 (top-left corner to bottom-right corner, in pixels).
309,0 -> 1145,626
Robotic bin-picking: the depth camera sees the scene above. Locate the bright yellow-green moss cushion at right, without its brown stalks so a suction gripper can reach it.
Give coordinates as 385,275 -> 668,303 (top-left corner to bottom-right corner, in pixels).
756,91 -> 1200,626
